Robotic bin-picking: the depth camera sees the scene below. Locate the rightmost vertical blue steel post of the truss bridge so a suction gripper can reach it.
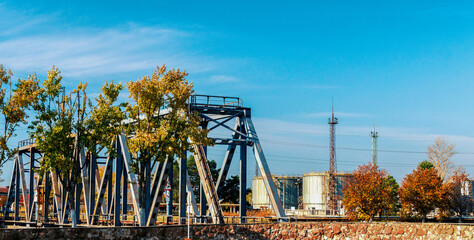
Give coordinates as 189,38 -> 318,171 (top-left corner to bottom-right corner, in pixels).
239,142 -> 247,223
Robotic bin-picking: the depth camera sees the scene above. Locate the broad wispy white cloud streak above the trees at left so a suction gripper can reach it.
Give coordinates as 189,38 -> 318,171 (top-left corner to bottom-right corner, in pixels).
0,26 -> 218,77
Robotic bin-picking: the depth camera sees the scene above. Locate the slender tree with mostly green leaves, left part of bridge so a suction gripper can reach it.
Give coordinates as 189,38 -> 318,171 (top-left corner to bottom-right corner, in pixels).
31,66 -> 87,227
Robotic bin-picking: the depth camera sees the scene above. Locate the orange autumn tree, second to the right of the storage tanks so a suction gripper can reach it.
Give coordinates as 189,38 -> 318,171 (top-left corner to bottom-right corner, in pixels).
399,162 -> 446,222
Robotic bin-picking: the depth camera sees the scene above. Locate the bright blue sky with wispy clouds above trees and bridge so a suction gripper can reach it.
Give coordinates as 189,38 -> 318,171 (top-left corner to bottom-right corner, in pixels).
0,1 -> 474,183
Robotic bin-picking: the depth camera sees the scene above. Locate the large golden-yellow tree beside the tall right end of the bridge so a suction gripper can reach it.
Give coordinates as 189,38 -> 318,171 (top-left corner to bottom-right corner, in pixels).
127,65 -> 210,224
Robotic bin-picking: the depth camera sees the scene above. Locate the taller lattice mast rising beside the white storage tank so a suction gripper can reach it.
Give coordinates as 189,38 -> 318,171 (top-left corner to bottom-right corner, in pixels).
328,104 -> 338,214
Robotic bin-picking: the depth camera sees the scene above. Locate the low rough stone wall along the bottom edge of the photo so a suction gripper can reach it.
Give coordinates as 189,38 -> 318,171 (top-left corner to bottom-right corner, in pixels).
0,222 -> 474,240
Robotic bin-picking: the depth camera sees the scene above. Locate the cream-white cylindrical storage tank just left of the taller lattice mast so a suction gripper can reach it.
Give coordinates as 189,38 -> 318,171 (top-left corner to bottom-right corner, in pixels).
303,172 -> 327,210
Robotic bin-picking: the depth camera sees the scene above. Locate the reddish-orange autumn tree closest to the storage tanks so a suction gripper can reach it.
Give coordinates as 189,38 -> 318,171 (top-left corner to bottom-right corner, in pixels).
342,163 -> 398,221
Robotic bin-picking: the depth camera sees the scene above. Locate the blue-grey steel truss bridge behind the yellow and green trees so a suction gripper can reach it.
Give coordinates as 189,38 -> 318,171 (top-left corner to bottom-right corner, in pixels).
3,95 -> 286,226
